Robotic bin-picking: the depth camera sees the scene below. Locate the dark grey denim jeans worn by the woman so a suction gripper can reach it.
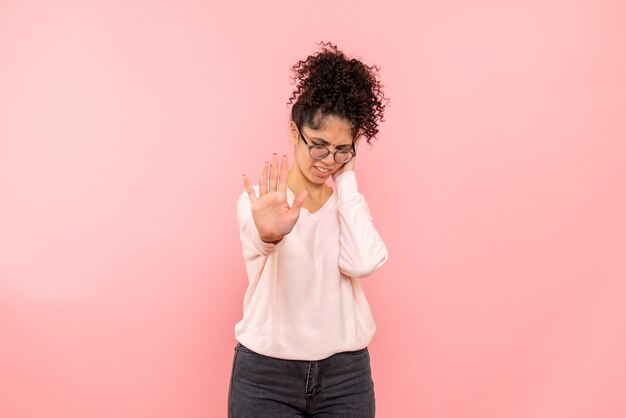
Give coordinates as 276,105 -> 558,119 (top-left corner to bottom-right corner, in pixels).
228,344 -> 375,418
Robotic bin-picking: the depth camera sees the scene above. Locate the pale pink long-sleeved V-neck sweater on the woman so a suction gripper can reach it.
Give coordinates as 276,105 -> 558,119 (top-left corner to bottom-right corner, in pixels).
235,171 -> 388,360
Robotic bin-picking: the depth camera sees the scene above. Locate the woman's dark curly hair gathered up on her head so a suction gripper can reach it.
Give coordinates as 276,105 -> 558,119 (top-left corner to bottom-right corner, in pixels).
287,42 -> 389,143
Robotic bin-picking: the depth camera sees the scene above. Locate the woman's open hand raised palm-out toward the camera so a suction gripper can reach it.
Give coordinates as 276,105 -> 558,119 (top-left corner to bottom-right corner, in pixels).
243,154 -> 308,243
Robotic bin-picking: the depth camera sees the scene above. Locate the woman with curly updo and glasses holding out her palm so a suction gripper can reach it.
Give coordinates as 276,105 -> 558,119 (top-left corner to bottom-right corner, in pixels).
228,44 -> 387,418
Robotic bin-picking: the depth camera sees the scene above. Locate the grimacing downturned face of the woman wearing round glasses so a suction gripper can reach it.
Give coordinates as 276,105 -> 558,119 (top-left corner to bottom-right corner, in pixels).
290,116 -> 353,185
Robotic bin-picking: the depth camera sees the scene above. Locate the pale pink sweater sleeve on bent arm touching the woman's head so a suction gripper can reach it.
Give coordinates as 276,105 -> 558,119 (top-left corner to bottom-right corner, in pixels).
335,171 -> 388,278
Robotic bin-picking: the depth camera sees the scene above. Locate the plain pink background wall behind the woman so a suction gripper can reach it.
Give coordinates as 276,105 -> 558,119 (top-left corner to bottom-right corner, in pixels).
0,0 -> 626,418
